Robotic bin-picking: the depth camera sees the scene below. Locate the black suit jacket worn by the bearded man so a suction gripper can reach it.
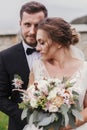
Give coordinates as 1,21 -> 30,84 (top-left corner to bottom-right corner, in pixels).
0,43 -> 29,130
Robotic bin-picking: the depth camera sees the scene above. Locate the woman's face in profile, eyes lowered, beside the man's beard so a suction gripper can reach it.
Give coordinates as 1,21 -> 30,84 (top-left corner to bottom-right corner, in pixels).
36,29 -> 58,60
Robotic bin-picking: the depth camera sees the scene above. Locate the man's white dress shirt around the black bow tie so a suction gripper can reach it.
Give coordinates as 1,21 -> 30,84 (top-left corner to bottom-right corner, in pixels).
23,41 -> 40,70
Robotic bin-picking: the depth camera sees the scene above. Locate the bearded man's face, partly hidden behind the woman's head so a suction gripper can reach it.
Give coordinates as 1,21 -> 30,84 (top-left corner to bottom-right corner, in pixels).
20,11 -> 44,47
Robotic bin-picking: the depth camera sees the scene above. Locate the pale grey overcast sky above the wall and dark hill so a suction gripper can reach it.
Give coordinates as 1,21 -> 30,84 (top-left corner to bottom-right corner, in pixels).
0,0 -> 87,30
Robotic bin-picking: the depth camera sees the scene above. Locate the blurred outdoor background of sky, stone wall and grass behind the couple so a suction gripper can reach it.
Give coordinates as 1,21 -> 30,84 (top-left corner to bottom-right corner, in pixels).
0,0 -> 87,130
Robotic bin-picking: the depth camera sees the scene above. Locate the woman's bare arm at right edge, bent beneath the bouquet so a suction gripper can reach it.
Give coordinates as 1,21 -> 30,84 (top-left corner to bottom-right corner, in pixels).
60,92 -> 87,130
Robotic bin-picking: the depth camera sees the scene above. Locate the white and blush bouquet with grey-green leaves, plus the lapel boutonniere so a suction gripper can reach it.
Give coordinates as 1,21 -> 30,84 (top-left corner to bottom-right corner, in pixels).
13,74 -> 82,130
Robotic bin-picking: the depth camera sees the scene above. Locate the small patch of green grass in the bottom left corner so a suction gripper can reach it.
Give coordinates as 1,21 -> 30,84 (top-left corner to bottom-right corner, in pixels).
0,112 -> 8,130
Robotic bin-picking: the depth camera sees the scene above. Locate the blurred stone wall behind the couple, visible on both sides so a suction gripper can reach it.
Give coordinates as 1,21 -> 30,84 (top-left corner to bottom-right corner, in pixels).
0,31 -> 87,60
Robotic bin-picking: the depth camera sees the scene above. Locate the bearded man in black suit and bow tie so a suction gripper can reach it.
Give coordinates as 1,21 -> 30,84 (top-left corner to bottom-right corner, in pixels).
0,1 -> 47,130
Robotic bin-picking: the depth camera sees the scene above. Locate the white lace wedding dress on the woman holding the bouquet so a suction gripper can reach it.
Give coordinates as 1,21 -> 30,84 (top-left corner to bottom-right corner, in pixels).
33,60 -> 87,130
